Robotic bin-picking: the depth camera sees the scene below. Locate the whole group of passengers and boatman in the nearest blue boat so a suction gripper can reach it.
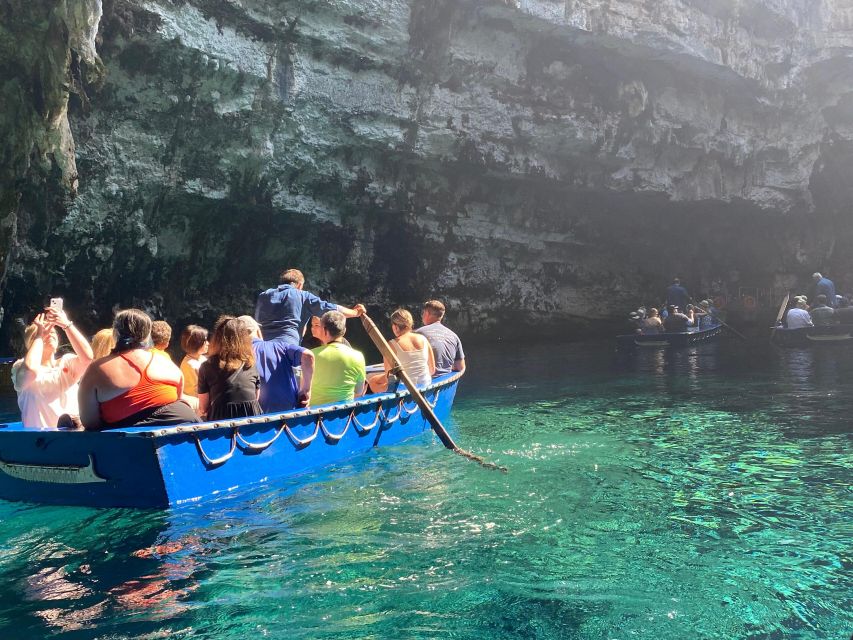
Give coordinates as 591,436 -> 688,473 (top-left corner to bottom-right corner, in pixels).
12,269 -> 465,431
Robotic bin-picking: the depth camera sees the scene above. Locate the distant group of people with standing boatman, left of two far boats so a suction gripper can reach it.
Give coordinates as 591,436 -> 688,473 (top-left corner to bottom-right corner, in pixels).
628,278 -> 720,335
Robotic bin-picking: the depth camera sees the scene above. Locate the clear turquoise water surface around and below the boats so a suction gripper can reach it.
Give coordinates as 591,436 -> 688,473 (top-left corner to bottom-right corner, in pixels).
0,342 -> 853,640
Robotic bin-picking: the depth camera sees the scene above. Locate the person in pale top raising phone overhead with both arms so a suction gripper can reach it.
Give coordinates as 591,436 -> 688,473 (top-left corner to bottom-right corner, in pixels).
12,308 -> 92,428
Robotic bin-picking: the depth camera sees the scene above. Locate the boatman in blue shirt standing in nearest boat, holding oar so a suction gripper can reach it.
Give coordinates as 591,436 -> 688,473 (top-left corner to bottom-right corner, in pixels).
255,269 -> 365,345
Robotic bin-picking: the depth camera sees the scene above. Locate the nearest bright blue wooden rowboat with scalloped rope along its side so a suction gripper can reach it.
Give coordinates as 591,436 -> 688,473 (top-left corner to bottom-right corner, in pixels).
0,373 -> 462,508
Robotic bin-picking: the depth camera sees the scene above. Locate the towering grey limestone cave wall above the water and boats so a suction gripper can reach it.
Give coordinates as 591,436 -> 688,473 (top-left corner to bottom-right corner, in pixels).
0,0 -> 853,336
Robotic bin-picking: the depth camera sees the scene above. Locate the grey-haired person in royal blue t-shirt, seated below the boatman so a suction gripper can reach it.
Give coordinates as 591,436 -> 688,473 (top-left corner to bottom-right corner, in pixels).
238,316 -> 314,413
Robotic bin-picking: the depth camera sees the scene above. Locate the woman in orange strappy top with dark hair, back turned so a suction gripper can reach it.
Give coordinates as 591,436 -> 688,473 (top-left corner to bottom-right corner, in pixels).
77,309 -> 198,431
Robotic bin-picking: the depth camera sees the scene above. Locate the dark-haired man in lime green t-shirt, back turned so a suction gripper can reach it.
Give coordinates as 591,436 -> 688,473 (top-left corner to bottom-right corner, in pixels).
311,311 -> 367,407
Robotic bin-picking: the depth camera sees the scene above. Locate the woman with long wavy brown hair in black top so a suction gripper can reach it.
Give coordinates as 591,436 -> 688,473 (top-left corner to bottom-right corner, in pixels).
198,316 -> 263,420
